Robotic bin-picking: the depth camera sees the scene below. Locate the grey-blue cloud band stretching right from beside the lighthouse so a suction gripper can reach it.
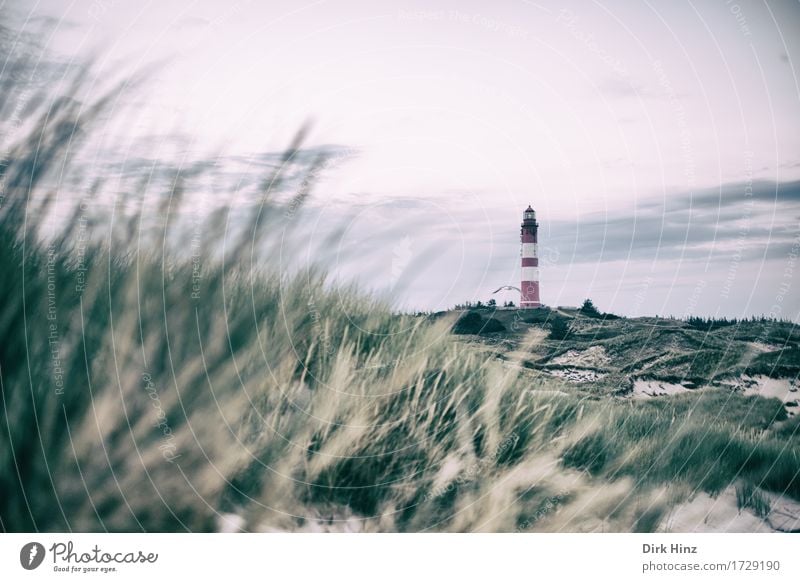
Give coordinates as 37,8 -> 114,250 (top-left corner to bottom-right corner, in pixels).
541,181 -> 800,263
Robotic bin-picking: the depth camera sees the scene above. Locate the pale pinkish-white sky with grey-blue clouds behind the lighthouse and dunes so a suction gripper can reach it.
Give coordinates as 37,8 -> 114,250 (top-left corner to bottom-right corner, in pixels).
0,0 -> 800,321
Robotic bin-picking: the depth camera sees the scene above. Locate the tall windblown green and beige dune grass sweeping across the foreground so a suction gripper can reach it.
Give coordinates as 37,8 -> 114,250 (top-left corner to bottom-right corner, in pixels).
0,67 -> 800,531
